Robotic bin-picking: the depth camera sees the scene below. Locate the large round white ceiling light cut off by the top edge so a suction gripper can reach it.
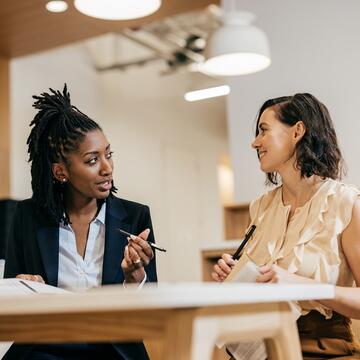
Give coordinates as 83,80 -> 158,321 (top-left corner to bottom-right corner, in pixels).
74,0 -> 161,20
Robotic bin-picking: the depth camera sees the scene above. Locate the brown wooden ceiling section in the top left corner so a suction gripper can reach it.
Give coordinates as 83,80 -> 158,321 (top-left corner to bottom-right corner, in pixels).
0,0 -> 220,58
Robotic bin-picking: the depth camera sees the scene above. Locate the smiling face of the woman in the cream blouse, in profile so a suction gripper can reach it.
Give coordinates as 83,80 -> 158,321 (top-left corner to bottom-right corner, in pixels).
252,107 -> 299,173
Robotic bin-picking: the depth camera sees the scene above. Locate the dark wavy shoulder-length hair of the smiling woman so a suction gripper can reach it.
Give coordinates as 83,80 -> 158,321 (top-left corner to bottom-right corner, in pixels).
255,93 -> 344,185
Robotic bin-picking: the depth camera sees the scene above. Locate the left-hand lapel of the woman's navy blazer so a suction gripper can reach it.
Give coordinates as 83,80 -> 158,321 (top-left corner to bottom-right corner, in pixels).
37,226 -> 59,286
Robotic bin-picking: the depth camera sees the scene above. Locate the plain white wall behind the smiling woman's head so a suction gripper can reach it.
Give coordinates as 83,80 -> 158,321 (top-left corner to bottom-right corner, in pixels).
227,0 -> 360,202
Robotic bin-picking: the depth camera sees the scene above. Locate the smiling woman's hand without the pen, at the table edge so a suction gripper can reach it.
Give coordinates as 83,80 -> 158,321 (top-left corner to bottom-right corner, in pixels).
256,265 -> 315,284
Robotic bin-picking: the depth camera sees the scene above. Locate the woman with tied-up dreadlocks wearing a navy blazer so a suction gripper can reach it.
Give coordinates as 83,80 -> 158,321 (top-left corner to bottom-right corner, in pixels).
5,85 -> 157,360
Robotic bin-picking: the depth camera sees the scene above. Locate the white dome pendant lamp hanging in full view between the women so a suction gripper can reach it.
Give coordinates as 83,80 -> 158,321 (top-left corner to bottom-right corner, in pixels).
201,11 -> 271,76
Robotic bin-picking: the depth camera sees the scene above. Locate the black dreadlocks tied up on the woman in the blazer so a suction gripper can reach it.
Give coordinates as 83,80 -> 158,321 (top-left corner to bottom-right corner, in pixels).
26,84 -> 116,224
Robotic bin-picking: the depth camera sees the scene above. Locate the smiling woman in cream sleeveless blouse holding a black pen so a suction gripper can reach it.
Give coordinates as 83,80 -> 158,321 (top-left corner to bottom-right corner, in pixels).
212,94 -> 360,359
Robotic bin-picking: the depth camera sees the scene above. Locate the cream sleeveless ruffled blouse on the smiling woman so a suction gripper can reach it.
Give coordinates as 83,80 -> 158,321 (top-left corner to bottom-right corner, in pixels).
239,179 -> 360,318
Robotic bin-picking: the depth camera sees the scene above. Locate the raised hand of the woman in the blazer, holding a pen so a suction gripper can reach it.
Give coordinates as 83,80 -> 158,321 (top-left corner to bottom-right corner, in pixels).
121,229 -> 154,283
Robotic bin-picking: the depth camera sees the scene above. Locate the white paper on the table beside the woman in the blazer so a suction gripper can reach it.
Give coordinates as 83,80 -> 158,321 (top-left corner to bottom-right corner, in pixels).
0,279 -> 68,297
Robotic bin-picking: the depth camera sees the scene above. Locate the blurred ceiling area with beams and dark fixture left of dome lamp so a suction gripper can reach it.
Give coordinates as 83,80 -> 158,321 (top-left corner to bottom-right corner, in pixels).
84,4 -> 222,75
